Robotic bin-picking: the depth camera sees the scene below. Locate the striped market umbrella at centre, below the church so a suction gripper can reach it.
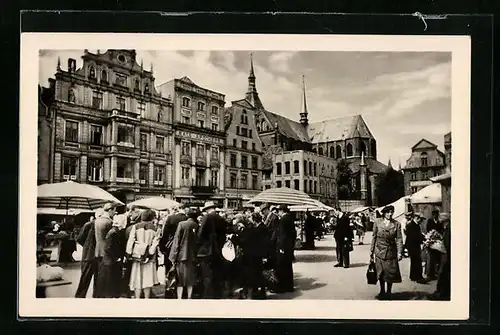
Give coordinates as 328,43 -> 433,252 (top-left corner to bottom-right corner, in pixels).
248,187 -> 318,206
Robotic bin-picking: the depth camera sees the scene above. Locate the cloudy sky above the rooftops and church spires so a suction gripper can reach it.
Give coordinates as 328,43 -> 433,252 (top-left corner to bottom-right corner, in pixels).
39,50 -> 451,168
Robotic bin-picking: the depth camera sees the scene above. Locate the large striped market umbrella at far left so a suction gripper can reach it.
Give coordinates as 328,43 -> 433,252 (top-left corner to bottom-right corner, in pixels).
37,181 -> 124,210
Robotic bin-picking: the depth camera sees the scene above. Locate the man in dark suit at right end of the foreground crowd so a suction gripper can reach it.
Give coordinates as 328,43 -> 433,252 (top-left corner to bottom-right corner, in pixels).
276,205 -> 297,293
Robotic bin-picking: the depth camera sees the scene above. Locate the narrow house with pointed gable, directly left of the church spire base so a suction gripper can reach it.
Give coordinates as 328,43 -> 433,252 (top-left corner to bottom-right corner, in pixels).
224,99 -> 262,208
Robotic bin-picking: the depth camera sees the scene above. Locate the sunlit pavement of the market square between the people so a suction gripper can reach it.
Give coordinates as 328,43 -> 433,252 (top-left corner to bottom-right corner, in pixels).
43,233 -> 436,300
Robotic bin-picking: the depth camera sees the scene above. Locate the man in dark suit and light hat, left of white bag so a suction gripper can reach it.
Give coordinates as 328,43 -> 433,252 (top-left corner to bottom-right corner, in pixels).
197,201 -> 226,299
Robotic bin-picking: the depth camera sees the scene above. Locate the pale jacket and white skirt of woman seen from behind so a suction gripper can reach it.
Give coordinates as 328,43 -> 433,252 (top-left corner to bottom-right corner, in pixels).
126,222 -> 159,291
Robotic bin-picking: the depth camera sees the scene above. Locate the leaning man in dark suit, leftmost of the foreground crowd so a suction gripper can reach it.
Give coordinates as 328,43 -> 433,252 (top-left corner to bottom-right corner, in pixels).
75,208 -> 103,298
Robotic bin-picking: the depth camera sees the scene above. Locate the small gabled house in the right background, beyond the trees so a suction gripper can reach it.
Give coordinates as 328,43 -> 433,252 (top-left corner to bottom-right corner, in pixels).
403,139 -> 445,195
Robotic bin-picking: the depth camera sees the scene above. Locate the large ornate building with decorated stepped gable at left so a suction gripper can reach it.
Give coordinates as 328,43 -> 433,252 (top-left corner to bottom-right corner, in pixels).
40,50 -> 174,202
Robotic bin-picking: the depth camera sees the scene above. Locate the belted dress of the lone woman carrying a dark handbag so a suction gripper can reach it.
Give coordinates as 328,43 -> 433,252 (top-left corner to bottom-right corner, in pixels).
371,219 -> 403,283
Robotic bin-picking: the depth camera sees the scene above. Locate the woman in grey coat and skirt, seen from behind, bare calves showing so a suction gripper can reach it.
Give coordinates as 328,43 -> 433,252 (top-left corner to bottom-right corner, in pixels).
169,208 -> 198,299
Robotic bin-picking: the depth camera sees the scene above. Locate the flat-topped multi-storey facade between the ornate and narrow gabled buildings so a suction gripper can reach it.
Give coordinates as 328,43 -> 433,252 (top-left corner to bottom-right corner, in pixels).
158,77 -> 226,206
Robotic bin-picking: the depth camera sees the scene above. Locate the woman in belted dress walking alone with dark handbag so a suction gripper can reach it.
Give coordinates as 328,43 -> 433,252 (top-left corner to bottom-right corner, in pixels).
370,206 -> 403,300
